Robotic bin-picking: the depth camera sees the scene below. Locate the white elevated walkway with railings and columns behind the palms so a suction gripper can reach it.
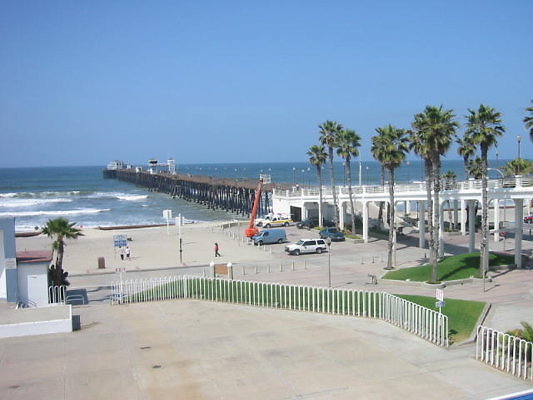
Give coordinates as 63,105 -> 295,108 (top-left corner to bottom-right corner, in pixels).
272,176 -> 533,268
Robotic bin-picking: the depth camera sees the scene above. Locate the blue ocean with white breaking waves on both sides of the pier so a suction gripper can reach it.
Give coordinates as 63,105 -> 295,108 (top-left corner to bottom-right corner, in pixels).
0,160 -> 505,231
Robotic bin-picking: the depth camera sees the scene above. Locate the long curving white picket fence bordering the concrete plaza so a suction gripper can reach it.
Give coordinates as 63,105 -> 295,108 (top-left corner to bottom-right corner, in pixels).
111,276 -> 448,347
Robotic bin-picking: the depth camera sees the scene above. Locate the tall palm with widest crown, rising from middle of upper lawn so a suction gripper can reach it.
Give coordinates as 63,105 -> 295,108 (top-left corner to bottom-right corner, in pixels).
413,106 -> 459,282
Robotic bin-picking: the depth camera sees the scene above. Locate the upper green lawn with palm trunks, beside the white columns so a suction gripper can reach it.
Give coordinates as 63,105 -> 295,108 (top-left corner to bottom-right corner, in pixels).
383,253 -> 514,282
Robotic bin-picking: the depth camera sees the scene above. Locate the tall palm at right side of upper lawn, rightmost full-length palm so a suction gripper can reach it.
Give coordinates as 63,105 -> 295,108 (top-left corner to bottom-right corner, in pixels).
466,104 -> 505,276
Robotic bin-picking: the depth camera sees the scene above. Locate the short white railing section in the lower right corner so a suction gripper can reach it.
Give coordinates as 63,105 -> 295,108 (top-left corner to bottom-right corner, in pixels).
476,325 -> 533,381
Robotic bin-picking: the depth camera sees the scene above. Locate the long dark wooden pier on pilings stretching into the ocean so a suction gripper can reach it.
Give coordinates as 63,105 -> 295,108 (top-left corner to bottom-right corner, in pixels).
103,168 -> 279,219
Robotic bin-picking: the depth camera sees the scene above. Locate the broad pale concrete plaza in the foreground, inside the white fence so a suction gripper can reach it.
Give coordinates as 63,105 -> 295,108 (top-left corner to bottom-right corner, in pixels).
0,300 -> 530,400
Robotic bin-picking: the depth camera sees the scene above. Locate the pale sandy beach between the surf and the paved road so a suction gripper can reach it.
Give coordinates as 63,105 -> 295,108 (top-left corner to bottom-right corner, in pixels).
17,221 -> 270,275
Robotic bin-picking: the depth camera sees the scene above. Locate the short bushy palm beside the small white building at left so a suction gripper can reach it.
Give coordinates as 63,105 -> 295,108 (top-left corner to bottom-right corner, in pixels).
43,217 -> 83,285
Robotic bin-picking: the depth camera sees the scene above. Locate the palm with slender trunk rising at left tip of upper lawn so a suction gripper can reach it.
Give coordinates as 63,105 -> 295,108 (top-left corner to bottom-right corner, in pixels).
370,124 -> 409,269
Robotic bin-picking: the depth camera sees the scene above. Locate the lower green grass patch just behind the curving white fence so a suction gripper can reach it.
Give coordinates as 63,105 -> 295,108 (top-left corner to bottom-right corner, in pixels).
396,294 -> 485,343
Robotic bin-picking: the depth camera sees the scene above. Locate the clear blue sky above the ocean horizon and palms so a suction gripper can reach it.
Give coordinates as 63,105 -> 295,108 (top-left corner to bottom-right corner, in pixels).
0,0 -> 533,167
